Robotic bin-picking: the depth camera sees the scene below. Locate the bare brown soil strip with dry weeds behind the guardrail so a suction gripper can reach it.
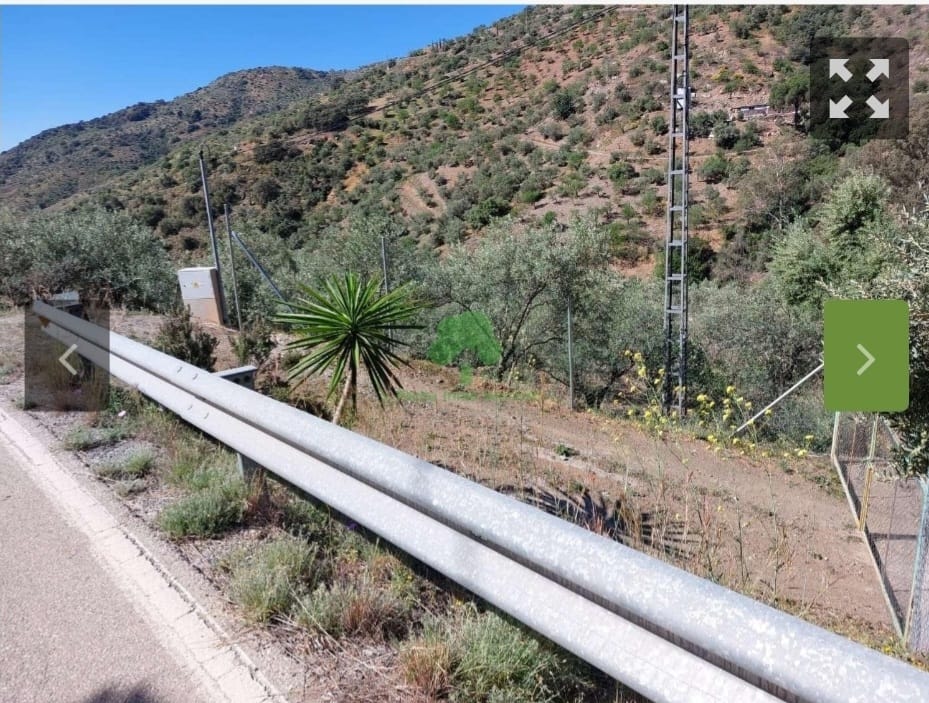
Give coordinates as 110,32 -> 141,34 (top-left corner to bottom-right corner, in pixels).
356,363 -> 891,639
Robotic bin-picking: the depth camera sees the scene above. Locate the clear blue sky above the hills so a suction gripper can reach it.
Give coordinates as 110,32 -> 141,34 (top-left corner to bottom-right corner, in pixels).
0,5 -> 521,151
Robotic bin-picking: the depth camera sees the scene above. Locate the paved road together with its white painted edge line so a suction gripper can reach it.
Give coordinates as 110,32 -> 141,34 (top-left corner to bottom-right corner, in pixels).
0,408 -> 283,703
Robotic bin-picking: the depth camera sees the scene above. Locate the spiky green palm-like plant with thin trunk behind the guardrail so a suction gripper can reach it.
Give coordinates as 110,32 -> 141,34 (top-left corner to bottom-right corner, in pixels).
274,273 -> 419,424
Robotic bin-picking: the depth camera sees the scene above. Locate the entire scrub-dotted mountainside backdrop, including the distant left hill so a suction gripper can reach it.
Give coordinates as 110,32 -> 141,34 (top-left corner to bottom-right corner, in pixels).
0,6 -> 929,280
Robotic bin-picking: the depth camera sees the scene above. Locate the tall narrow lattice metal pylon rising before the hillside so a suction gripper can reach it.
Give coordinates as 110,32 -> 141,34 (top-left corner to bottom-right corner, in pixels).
664,5 -> 691,416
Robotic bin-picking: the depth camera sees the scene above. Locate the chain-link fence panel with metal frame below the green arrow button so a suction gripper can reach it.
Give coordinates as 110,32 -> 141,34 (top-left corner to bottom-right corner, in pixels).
832,413 -> 929,652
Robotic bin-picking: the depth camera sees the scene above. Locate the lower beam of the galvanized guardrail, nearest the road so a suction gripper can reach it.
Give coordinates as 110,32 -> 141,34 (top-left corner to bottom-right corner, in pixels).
34,310 -> 778,703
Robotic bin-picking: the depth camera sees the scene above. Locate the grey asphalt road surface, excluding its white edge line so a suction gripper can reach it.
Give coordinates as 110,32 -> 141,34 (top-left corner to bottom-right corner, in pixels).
0,443 -> 210,703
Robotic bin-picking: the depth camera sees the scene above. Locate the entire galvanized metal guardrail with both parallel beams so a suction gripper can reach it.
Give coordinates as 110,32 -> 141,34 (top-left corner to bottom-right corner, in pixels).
35,302 -> 929,703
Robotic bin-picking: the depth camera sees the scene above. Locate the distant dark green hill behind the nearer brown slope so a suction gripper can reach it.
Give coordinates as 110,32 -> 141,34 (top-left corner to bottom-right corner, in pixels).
0,67 -> 335,209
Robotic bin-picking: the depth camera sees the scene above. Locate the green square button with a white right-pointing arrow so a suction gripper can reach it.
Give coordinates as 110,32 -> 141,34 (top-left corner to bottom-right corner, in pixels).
823,300 -> 910,412
